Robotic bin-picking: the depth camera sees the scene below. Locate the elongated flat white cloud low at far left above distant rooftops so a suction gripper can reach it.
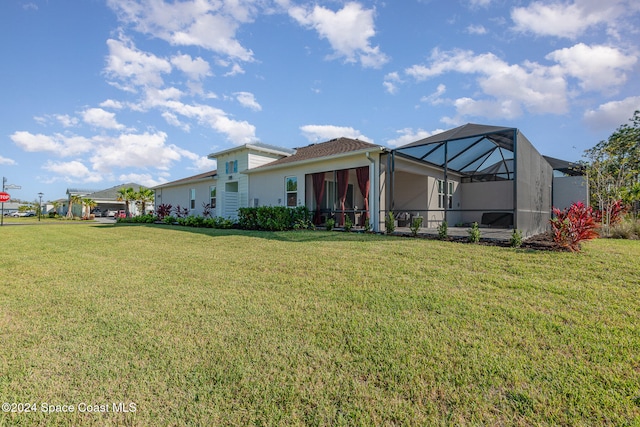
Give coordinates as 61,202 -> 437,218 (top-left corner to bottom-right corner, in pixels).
9,131 -> 92,157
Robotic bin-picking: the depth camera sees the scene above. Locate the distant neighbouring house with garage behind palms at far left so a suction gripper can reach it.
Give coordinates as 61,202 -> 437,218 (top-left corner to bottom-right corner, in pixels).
64,182 -> 154,216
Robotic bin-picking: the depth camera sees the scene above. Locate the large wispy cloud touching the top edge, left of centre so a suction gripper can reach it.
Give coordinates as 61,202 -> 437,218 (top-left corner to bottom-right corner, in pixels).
107,0 -> 256,61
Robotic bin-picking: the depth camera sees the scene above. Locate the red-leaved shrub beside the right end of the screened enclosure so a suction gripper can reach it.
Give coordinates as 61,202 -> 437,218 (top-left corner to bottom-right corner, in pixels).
550,202 -> 598,252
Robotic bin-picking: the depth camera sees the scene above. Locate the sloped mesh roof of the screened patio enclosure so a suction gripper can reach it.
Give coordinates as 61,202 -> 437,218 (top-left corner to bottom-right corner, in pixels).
393,124 -> 518,181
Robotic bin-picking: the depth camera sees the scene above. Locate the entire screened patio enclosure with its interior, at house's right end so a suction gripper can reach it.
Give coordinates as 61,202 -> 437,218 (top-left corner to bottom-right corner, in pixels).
384,124 -> 553,235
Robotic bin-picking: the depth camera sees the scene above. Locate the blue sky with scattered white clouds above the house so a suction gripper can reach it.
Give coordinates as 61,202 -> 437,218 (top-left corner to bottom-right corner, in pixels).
0,0 -> 640,200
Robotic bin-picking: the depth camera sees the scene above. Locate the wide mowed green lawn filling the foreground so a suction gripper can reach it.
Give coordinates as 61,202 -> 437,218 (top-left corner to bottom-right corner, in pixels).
0,226 -> 640,426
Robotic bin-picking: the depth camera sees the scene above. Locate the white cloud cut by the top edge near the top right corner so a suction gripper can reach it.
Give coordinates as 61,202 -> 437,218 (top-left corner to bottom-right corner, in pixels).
511,0 -> 637,39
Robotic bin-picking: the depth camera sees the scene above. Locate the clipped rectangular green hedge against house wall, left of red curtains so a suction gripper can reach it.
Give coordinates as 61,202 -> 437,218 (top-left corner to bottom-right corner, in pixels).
238,206 -> 312,231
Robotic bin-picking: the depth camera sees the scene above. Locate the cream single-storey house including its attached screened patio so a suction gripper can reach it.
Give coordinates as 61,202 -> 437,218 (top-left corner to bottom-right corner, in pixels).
154,124 -> 588,236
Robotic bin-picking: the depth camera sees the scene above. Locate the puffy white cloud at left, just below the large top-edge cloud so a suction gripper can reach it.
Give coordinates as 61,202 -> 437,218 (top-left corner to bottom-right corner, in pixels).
105,39 -> 171,92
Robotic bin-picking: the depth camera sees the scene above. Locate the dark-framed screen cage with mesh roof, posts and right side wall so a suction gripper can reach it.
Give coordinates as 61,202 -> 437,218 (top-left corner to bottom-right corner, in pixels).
390,123 -> 553,235
